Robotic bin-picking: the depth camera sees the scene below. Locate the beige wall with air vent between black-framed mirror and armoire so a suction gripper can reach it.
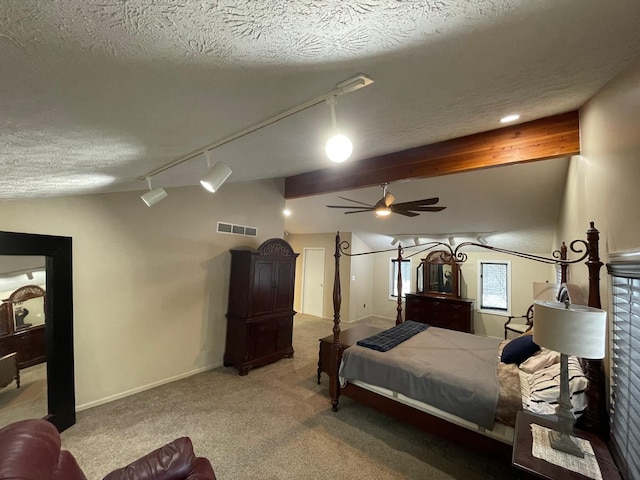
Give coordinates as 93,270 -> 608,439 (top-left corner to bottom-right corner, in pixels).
0,181 -> 284,408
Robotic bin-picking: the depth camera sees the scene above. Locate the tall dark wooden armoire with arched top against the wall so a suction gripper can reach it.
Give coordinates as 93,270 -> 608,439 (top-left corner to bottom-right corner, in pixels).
224,238 -> 298,375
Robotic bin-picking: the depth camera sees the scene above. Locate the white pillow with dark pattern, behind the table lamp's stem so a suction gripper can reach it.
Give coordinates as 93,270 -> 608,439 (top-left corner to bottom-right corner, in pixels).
522,357 -> 589,417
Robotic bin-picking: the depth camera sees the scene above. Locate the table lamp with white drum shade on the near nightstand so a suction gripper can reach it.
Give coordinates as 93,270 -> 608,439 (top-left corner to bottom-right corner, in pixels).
533,301 -> 607,457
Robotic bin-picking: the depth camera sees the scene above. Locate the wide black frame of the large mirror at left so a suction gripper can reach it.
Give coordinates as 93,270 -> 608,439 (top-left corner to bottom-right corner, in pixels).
0,232 -> 76,431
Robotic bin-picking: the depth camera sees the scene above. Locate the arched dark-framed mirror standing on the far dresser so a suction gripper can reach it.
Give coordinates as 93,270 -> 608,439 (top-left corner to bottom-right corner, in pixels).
421,250 -> 460,298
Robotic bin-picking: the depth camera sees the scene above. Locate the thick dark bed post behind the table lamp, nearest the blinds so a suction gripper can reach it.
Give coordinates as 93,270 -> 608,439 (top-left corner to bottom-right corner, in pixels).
578,222 -> 609,439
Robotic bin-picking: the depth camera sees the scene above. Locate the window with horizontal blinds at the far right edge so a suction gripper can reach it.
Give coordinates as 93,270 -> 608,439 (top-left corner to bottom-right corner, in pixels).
607,261 -> 640,478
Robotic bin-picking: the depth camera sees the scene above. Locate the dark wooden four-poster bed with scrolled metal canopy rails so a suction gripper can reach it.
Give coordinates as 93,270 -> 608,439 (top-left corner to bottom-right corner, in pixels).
328,222 -> 608,459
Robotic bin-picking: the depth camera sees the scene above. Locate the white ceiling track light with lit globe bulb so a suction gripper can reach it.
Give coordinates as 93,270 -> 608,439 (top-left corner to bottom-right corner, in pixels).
138,73 -> 373,201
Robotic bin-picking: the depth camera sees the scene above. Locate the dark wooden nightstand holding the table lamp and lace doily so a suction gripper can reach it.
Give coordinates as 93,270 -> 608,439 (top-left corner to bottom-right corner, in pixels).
511,411 -> 621,480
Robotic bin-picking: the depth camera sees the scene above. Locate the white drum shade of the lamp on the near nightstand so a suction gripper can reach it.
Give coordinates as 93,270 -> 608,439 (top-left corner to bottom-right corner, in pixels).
533,301 -> 607,358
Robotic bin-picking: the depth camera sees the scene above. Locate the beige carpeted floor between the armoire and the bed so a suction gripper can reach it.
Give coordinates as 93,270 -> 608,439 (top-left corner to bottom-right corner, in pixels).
62,315 -> 518,480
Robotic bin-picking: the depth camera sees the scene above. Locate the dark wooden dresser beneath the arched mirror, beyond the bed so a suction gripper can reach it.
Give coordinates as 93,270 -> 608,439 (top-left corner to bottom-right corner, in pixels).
405,293 -> 473,333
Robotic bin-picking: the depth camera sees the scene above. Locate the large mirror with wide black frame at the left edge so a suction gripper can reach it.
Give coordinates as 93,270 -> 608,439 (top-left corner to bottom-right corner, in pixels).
0,232 -> 75,431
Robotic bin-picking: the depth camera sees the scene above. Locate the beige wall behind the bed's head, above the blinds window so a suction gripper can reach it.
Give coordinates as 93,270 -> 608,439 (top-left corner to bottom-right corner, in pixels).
556,53 -> 640,308
